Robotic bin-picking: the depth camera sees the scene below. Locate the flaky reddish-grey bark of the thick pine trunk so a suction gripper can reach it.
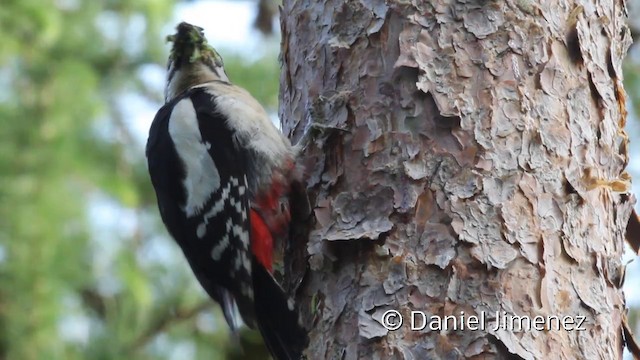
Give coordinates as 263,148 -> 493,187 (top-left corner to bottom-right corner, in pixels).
281,0 -> 634,359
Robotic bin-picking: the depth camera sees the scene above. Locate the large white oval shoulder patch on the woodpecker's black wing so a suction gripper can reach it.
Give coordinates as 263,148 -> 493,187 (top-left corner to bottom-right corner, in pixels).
169,99 -> 220,217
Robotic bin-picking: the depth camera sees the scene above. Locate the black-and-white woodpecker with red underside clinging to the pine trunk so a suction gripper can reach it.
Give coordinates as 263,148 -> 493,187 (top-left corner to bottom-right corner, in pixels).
146,22 -> 307,360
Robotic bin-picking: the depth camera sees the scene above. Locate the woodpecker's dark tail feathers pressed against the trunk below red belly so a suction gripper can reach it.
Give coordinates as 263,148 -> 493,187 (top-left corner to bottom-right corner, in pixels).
252,259 -> 308,360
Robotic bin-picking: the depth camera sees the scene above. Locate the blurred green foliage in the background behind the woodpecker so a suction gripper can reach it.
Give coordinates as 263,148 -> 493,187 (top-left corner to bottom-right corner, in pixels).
0,0 -> 278,360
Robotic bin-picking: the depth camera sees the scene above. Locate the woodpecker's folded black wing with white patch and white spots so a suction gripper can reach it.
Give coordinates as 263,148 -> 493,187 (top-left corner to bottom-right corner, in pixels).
146,89 -> 255,328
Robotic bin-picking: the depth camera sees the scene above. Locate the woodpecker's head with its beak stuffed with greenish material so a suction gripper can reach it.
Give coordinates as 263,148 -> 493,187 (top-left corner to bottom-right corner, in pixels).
165,22 -> 229,102
